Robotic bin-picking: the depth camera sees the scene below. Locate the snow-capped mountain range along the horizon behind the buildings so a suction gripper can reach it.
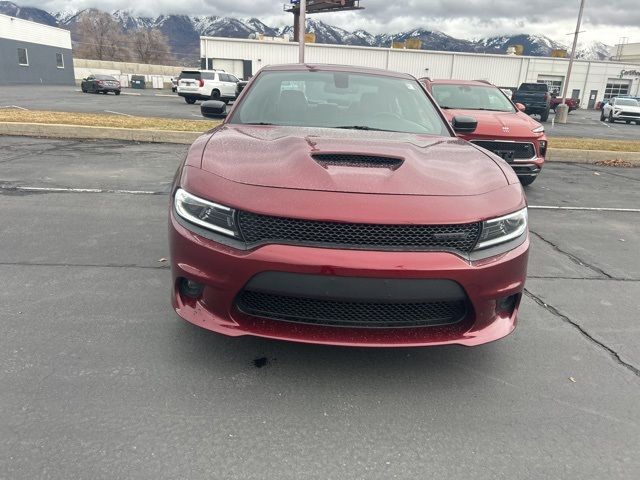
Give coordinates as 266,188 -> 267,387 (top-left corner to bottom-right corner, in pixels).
0,1 -> 610,63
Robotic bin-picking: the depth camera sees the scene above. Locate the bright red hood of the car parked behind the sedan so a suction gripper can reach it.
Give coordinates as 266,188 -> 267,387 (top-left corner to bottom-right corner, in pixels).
444,109 -> 540,139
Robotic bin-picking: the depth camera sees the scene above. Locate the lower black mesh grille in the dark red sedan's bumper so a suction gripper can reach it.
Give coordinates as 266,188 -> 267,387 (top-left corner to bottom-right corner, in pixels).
236,290 -> 467,328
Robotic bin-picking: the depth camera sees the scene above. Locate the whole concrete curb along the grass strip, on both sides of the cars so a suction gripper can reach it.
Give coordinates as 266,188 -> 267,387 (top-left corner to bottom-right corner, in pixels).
0,122 -> 640,165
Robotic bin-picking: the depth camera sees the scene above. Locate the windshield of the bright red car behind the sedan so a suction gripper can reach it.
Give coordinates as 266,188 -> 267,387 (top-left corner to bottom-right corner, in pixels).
432,85 -> 516,112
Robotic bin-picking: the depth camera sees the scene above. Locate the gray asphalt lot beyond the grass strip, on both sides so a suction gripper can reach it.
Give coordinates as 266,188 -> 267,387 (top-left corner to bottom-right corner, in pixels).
0,86 -> 640,140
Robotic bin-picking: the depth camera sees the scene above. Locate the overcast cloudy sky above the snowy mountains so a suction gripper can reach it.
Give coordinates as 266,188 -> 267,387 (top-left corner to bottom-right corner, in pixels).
23,0 -> 640,45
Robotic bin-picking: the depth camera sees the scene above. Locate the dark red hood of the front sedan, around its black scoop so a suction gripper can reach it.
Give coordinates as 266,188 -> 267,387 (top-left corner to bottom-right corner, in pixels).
201,124 -> 508,196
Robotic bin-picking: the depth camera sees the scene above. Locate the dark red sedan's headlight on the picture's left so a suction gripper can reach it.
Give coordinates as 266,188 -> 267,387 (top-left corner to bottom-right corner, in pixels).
173,188 -> 240,237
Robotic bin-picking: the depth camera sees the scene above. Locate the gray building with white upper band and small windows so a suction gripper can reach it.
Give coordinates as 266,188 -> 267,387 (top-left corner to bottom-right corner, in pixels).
0,15 -> 75,85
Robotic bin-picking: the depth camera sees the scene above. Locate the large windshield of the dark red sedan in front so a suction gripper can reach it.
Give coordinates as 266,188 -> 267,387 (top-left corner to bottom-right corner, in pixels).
229,71 -> 450,136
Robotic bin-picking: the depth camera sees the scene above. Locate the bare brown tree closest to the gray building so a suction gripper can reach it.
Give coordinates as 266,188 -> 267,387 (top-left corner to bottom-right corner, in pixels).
76,9 -> 129,61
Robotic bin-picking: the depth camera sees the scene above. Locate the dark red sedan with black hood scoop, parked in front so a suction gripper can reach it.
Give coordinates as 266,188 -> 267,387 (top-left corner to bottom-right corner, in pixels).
169,65 -> 529,347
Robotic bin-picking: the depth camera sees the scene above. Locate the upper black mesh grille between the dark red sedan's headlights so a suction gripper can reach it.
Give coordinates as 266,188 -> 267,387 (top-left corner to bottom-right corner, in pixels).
238,211 -> 480,253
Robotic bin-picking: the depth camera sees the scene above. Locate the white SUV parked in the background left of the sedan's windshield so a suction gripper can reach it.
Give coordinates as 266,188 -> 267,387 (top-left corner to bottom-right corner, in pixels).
178,70 -> 239,104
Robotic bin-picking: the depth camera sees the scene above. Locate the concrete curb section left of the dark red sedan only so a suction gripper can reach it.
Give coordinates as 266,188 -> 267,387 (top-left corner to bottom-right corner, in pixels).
0,122 -> 202,145
